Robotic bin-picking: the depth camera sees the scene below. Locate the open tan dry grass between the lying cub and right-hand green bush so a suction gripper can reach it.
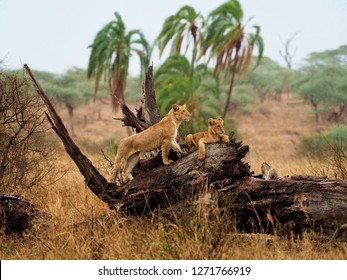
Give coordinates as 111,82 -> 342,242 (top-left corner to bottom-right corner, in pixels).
237,95 -> 330,176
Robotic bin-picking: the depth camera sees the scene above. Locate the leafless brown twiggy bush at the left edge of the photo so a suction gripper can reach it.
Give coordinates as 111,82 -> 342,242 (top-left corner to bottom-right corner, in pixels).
0,73 -> 56,193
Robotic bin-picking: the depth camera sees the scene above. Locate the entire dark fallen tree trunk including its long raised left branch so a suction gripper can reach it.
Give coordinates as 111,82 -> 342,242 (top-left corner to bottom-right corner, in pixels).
24,65 -> 347,240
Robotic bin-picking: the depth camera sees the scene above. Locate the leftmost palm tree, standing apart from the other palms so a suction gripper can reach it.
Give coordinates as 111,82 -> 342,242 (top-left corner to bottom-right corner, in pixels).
87,12 -> 151,110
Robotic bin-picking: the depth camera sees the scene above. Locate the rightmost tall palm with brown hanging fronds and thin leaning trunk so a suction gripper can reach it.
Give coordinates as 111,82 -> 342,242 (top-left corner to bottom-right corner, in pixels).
199,0 -> 264,118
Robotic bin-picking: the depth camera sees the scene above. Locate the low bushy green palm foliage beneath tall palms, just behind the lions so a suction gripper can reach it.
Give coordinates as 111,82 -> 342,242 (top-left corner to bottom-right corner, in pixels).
154,55 -> 220,132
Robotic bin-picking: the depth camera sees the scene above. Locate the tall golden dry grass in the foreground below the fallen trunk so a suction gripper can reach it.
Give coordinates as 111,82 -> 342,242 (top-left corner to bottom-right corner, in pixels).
0,171 -> 347,260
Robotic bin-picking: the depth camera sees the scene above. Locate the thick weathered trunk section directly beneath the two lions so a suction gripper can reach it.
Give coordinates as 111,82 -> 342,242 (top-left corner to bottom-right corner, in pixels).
104,139 -> 251,213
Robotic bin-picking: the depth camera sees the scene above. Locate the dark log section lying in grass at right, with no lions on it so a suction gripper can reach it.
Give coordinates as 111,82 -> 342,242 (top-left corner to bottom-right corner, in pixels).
218,175 -> 347,239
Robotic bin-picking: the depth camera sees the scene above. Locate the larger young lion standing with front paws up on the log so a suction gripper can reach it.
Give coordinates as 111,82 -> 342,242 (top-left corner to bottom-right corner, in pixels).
111,104 -> 192,182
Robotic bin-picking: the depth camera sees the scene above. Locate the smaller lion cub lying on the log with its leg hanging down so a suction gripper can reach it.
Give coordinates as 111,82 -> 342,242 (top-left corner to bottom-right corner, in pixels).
186,118 -> 230,160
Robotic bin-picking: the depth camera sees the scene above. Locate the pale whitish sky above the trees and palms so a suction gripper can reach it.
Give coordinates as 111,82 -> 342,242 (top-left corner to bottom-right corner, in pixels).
0,0 -> 347,75
